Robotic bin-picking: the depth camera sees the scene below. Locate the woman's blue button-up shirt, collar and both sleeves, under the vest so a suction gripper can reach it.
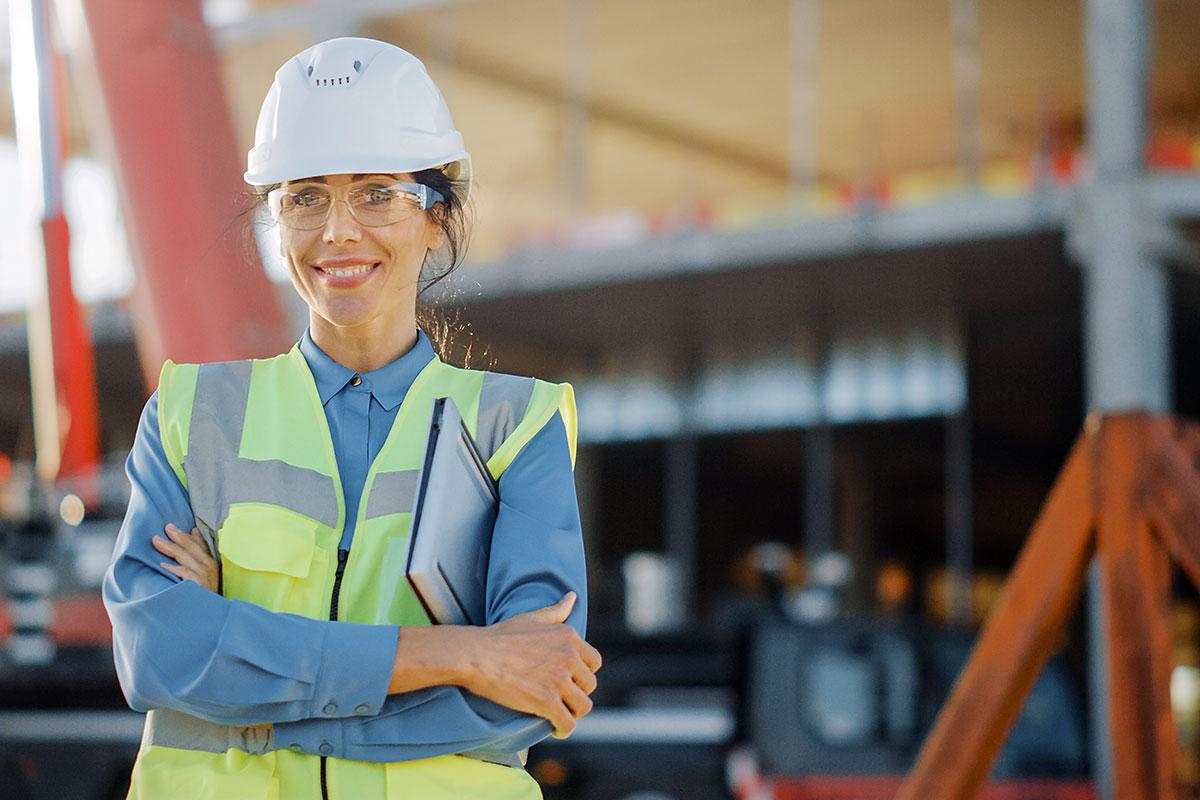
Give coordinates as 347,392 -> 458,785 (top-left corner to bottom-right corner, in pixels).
103,331 -> 587,762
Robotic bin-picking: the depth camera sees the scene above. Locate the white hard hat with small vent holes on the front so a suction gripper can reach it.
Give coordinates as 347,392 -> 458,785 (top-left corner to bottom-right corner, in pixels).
245,37 -> 470,201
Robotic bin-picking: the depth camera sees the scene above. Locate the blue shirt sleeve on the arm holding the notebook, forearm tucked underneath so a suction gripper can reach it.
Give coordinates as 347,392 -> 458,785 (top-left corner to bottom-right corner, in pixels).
275,413 -> 587,762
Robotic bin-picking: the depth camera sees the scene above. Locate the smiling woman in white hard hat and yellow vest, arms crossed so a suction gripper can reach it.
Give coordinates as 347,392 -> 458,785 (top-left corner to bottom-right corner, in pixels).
104,38 -> 600,800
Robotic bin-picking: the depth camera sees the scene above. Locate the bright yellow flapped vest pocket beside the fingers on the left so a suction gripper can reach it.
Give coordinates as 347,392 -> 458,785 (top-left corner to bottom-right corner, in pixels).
217,503 -> 329,618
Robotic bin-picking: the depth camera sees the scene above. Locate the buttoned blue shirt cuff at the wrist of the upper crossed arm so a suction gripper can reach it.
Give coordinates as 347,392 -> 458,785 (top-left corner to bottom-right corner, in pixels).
308,622 -> 400,718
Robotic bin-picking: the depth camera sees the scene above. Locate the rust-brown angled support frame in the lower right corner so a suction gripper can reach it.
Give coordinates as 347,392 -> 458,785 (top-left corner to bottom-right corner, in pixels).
896,414 -> 1200,800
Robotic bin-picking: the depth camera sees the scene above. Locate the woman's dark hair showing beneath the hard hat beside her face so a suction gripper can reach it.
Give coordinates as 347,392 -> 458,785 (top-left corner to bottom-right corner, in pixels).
239,168 -> 474,366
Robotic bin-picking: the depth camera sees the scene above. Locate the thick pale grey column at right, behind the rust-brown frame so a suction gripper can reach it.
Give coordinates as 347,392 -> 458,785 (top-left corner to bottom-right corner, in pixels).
1079,0 -> 1171,800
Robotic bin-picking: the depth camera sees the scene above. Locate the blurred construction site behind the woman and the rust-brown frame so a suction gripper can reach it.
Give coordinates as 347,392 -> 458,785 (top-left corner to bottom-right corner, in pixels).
0,0 -> 1200,800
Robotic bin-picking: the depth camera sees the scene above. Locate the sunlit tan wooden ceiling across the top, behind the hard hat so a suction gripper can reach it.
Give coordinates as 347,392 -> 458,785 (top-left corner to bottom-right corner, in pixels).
0,0 -> 1200,253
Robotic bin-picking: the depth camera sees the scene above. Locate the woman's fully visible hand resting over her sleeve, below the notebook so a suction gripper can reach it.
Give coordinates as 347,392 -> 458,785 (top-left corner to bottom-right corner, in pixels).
460,591 -> 601,739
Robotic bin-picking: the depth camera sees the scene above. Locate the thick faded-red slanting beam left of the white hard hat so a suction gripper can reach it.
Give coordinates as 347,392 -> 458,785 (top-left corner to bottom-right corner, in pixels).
73,0 -> 294,386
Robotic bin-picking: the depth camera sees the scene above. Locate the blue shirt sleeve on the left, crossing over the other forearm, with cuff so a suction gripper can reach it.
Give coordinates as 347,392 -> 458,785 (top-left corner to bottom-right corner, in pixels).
103,392 -> 400,724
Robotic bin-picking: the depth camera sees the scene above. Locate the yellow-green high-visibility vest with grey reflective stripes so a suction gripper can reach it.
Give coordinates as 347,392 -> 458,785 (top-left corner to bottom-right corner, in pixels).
128,347 -> 575,800
